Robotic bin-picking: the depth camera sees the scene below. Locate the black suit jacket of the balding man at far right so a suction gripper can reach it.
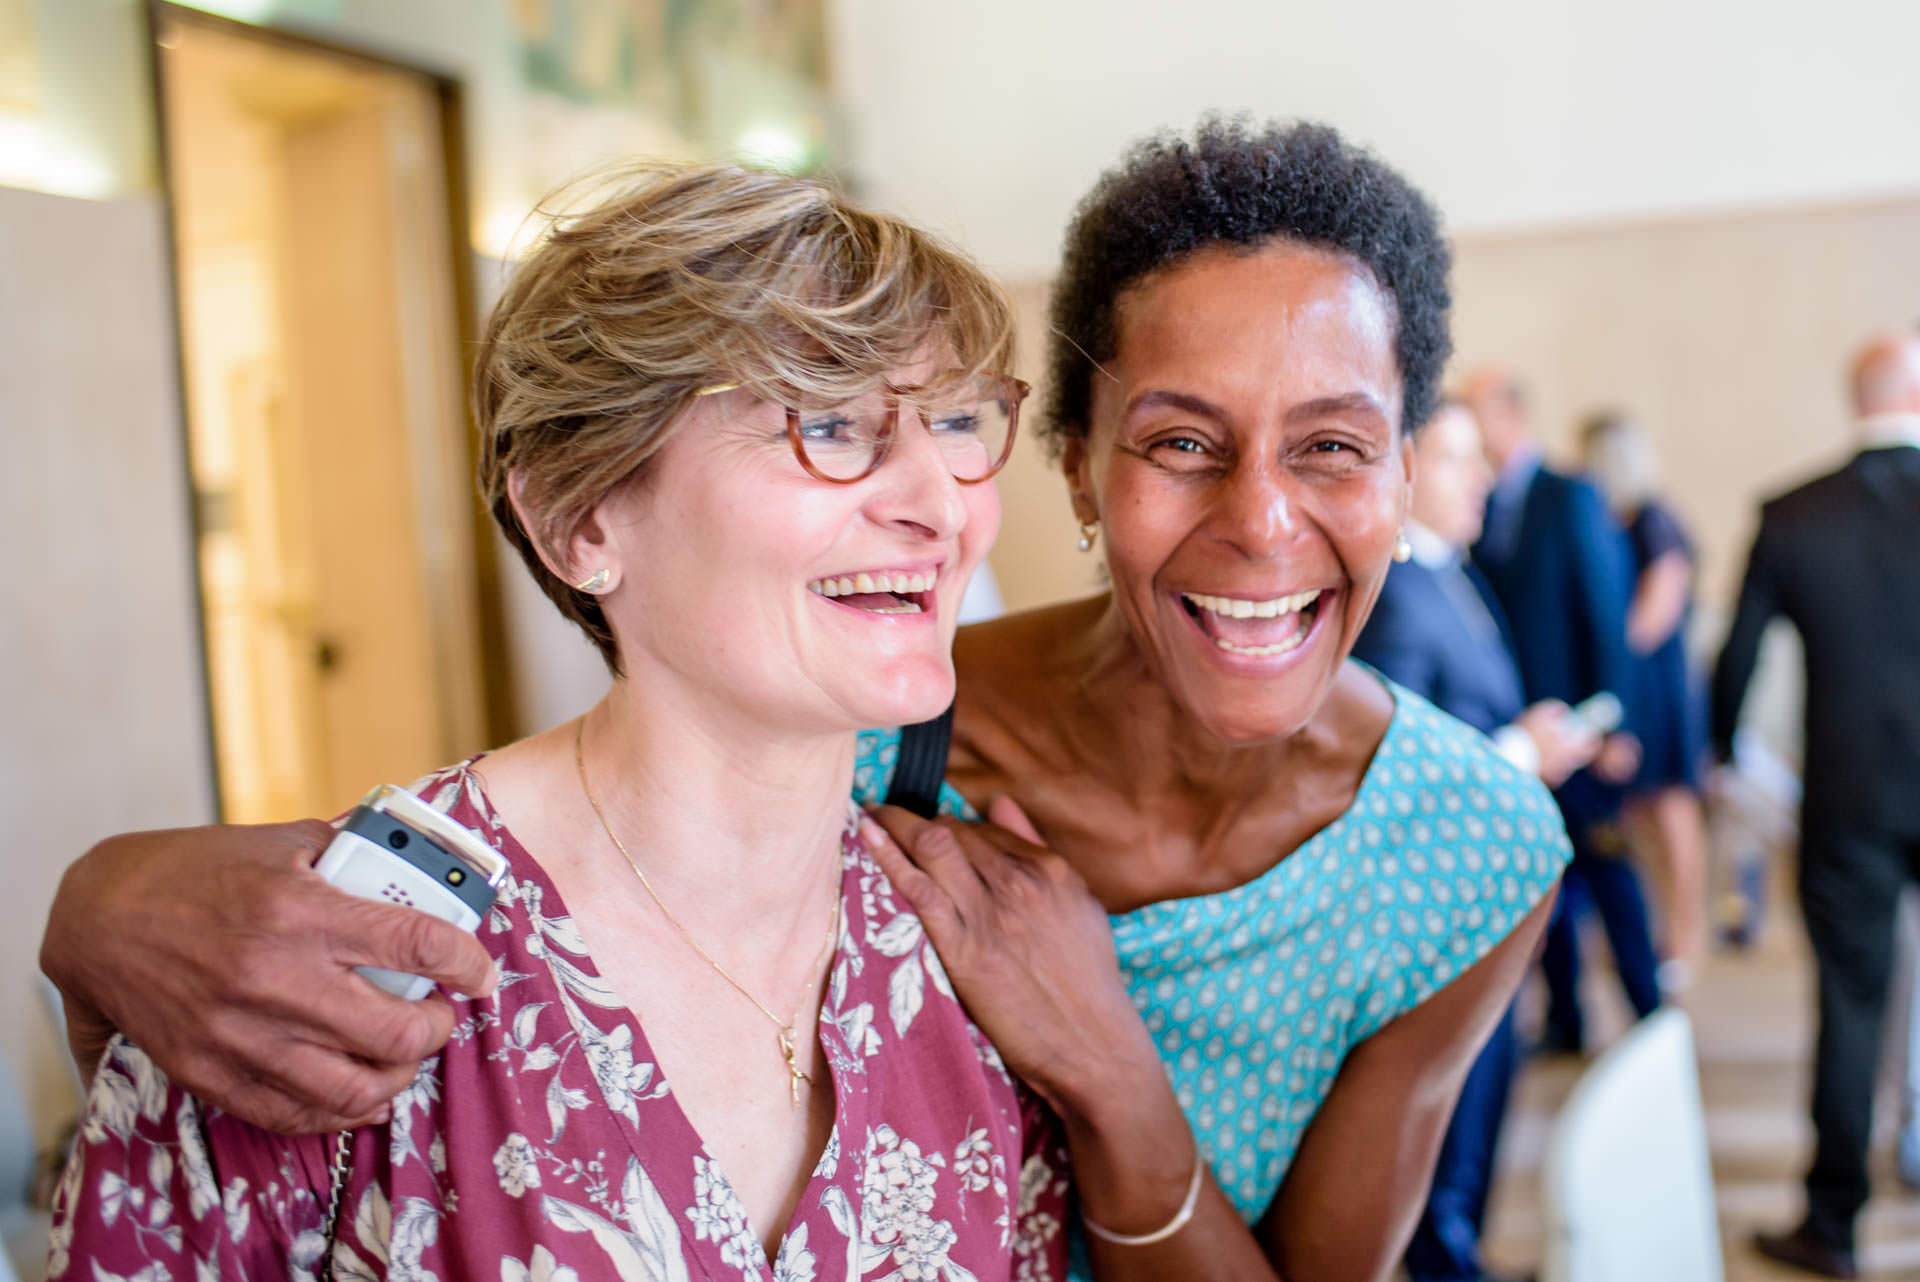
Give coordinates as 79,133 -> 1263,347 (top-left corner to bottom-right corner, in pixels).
1713,445 -> 1920,837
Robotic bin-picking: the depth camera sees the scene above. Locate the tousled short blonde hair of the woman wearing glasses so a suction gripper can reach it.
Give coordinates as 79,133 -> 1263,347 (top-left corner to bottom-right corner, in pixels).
474,165 -> 1012,674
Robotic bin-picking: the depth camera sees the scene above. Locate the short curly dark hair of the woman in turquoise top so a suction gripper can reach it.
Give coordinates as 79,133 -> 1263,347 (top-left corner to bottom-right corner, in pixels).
1041,117 -> 1453,455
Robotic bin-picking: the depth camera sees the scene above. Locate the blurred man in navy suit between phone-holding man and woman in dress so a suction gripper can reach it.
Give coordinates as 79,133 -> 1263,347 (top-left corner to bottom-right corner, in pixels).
1463,368 -> 1661,1054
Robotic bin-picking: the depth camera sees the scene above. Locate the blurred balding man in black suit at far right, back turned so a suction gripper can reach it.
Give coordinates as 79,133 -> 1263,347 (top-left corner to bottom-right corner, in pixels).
1713,334 -> 1920,1278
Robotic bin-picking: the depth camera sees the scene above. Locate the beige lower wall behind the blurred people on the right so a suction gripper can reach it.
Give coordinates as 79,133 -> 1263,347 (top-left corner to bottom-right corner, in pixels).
1453,196 -> 1920,606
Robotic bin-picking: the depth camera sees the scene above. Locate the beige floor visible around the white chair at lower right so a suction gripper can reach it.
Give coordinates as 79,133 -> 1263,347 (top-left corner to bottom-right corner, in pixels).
1486,908 -> 1920,1282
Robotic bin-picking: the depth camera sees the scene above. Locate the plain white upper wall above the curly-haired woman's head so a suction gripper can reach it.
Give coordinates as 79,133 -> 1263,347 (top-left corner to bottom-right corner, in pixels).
831,0 -> 1920,278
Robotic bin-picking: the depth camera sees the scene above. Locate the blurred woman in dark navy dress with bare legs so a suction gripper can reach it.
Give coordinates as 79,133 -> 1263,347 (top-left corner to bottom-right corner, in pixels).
1580,411 -> 1707,992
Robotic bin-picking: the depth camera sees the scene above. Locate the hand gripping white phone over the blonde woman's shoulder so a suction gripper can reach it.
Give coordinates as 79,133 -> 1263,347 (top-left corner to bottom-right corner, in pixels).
40,819 -> 492,1130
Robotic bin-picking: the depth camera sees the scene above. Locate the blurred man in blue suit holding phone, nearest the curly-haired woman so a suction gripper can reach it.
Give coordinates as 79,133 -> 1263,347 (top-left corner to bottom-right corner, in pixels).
1354,403 -> 1599,1282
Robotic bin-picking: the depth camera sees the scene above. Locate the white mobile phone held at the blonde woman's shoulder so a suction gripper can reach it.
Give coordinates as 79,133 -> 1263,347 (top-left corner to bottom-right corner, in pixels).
313,783 -> 507,1002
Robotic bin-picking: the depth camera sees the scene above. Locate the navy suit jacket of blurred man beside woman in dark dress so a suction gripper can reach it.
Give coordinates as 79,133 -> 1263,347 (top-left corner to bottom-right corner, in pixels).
1473,466 -> 1634,827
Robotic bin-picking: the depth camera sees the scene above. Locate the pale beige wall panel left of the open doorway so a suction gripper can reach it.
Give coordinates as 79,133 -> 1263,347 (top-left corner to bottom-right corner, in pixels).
0,188 -> 213,1140
